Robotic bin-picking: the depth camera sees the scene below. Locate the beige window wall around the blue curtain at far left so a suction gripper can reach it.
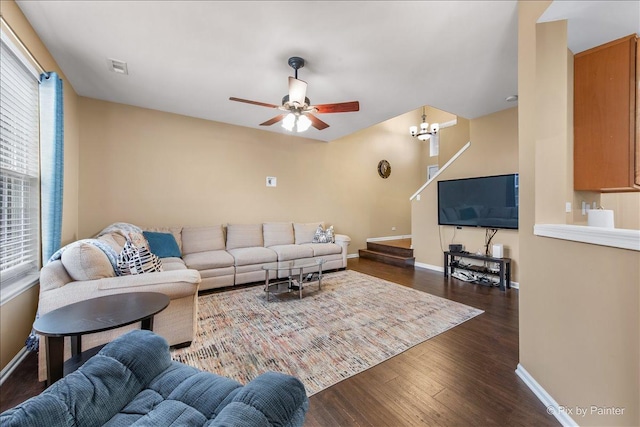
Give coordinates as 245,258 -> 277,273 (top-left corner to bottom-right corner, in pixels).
0,0 -> 79,368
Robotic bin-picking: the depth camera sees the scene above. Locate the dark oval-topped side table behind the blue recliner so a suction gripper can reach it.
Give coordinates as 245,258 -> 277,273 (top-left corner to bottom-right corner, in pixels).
33,292 -> 170,386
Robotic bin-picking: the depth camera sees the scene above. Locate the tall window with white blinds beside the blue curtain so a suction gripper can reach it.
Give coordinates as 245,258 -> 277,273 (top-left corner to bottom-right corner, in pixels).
0,31 -> 40,302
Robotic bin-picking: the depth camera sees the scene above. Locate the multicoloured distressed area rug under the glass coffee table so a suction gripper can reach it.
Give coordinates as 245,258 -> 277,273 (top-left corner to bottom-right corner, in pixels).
171,270 -> 482,396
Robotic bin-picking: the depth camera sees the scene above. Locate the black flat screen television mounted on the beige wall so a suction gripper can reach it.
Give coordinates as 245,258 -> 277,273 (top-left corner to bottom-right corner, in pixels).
438,174 -> 518,229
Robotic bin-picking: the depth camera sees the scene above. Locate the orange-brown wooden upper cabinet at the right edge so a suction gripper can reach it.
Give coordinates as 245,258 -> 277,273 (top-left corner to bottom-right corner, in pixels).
573,34 -> 640,192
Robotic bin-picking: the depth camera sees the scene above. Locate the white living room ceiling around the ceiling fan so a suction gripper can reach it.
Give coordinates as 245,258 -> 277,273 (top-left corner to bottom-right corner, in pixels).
17,0 -> 636,141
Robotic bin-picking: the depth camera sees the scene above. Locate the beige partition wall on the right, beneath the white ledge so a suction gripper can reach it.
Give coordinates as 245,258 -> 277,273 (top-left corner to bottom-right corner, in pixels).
518,1 -> 640,426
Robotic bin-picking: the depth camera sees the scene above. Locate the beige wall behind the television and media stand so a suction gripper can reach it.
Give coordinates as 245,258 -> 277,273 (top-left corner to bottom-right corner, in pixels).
411,108 -> 519,281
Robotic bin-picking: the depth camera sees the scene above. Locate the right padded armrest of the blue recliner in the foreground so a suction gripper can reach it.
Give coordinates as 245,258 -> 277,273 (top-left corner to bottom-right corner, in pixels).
210,372 -> 309,426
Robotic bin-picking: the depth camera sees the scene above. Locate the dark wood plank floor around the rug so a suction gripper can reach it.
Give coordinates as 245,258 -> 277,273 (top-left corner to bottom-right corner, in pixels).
0,258 -> 558,427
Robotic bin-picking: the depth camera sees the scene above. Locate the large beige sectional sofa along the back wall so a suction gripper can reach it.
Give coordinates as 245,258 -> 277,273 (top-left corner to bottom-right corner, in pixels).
38,222 -> 350,381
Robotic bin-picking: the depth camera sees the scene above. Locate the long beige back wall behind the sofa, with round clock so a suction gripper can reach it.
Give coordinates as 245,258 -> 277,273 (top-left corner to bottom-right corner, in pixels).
80,98 -> 420,253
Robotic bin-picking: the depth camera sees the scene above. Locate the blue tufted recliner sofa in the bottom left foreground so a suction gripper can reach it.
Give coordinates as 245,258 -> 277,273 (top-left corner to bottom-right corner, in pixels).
0,330 -> 309,427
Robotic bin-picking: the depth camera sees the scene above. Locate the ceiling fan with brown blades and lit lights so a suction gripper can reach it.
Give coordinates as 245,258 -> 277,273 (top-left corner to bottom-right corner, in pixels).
229,56 -> 360,132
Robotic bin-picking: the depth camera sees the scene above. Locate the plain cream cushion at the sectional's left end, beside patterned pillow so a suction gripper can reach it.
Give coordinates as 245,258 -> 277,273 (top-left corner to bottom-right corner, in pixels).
60,241 -> 116,281
